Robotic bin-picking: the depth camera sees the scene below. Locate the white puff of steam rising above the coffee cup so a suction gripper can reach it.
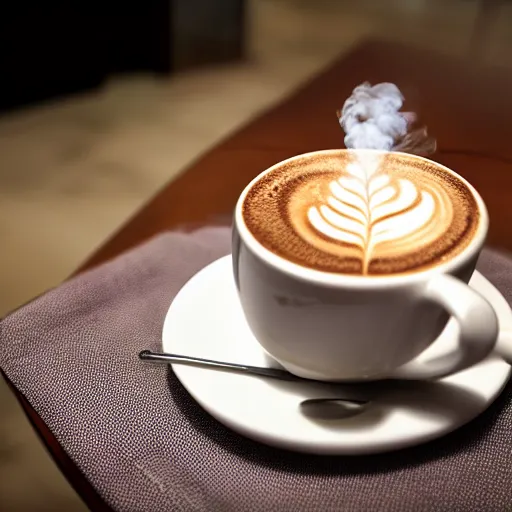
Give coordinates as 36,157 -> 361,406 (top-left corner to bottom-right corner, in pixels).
338,82 -> 436,155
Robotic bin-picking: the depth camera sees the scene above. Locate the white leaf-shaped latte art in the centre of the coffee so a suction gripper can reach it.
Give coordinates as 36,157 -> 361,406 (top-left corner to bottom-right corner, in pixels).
307,154 -> 452,274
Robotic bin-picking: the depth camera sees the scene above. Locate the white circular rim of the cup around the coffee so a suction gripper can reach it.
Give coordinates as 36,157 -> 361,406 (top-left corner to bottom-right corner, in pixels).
234,149 -> 489,289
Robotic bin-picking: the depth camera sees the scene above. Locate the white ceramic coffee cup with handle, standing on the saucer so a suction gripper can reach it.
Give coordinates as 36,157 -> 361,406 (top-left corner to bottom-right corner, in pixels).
233,148 -> 498,381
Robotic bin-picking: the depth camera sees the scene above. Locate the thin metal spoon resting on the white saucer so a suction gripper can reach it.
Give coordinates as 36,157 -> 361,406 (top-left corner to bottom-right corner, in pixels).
139,350 -> 370,415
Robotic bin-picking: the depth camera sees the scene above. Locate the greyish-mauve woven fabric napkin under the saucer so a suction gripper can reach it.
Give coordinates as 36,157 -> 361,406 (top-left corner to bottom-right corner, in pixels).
0,228 -> 512,512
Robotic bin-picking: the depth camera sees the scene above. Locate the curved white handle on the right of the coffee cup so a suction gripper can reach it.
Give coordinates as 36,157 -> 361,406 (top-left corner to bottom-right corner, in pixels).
391,274 -> 499,380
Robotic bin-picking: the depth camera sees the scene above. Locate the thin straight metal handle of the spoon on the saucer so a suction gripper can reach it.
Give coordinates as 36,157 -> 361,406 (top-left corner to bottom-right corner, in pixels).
139,350 -> 300,381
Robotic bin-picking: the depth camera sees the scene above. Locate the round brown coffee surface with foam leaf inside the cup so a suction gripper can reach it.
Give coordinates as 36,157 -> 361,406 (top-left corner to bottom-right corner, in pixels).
242,151 -> 480,275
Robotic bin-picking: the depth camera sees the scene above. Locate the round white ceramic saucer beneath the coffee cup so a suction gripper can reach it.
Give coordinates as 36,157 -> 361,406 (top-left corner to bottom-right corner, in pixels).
163,256 -> 512,455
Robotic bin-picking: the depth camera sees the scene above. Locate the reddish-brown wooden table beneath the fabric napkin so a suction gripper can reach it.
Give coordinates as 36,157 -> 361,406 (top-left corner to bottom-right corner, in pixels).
8,41 -> 512,510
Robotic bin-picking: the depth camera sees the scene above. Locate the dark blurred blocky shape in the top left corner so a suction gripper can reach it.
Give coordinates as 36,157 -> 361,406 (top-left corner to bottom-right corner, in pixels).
0,0 -> 246,111
